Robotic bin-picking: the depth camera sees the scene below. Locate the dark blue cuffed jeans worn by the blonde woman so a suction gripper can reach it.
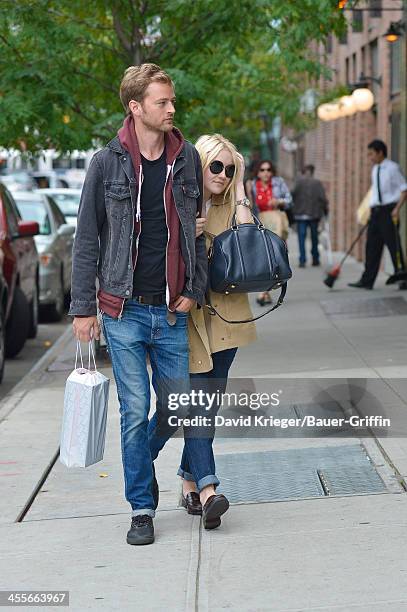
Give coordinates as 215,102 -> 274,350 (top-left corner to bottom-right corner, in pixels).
178,348 -> 237,491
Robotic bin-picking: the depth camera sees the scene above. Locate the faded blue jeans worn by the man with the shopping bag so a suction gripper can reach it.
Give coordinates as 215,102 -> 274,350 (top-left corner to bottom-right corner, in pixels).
102,299 -> 190,516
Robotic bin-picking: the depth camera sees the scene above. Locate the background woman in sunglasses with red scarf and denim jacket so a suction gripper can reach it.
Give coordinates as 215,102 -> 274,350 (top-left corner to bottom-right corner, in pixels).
246,159 -> 292,306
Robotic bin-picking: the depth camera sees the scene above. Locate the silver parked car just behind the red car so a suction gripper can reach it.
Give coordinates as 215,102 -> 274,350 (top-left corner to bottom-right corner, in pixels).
15,191 -> 75,321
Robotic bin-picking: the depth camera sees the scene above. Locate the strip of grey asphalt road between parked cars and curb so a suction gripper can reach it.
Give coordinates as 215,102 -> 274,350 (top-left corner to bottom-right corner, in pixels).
0,315 -> 72,401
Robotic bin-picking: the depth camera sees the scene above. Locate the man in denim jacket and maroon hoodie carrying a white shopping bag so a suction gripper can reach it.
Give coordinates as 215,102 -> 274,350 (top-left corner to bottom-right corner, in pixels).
69,64 -> 207,544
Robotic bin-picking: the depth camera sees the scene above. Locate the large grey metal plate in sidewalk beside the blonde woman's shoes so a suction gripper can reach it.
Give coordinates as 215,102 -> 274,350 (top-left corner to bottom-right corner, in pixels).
216,444 -> 387,503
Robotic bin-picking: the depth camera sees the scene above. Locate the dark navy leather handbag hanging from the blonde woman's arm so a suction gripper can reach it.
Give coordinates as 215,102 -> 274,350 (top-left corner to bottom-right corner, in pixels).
207,213 -> 292,323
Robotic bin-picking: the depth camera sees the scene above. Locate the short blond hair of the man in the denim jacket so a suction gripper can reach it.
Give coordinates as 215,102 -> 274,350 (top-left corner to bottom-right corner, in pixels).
120,64 -> 174,115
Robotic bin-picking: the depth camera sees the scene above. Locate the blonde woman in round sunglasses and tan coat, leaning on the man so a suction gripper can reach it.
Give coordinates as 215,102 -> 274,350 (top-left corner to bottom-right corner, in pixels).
178,134 -> 256,529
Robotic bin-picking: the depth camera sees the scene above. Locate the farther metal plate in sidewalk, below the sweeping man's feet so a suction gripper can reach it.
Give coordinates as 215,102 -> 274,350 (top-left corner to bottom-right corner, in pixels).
320,297 -> 407,319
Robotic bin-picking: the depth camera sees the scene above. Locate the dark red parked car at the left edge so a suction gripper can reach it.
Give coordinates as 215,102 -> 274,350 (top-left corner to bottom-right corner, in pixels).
0,183 -> 39,357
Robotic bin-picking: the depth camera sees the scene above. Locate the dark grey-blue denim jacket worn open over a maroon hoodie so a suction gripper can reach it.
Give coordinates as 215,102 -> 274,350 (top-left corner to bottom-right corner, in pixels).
69,137 -> 207,316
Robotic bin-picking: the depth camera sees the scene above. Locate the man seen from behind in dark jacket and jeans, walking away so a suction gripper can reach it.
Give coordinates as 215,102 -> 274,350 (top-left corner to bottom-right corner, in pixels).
292,164 -> 328,268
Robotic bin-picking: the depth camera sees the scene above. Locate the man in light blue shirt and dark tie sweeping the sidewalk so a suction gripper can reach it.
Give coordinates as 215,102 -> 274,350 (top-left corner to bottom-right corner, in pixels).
349,140 -> 407,289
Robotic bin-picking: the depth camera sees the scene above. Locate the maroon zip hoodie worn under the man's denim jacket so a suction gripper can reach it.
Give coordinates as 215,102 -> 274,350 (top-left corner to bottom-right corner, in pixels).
98,116 -> 185,318
